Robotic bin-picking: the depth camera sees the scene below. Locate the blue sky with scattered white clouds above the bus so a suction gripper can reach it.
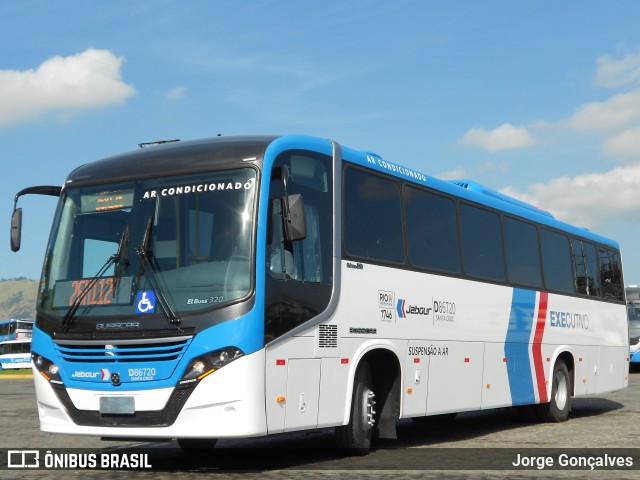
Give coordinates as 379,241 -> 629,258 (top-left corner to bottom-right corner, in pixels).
0,0 -> 640,284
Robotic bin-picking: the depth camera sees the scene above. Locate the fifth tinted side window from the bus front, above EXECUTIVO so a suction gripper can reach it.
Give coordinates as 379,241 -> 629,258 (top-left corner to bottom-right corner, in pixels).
540,228 -> 574,293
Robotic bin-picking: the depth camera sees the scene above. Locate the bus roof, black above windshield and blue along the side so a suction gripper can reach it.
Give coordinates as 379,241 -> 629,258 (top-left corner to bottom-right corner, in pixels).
65,135 -> 619,249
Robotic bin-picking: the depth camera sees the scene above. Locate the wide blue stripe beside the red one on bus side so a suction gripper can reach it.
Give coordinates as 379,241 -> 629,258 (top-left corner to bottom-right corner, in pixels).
504,288 -> 536,405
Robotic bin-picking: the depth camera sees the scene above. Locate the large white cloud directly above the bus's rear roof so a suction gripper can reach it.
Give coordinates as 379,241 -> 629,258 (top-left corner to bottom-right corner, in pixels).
501,165 -> 640,227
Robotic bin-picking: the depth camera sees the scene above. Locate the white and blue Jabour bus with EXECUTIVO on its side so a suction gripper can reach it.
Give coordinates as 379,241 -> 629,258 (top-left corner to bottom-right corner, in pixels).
12,136 -> 629,452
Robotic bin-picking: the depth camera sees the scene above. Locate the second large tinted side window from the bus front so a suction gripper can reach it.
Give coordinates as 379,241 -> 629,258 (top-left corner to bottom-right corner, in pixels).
403,187 -> 460,273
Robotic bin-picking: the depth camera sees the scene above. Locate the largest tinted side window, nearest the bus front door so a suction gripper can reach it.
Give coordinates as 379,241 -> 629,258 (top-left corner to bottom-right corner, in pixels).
343,168 -> 404,263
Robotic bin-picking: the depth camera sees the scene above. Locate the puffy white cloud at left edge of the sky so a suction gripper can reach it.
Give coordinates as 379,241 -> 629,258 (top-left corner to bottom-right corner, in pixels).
0,49 -> 135,127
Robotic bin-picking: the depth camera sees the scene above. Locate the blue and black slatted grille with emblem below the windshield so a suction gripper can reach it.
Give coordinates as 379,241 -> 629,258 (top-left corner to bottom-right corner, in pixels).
55,337 -> 191,363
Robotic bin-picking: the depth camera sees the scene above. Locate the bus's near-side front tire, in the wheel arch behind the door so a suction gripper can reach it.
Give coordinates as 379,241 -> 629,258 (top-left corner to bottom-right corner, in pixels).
336,362 -> 377,455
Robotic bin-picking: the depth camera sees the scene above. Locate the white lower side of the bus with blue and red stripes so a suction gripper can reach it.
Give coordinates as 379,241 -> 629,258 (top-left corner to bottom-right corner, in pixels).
266,261 -> 627,433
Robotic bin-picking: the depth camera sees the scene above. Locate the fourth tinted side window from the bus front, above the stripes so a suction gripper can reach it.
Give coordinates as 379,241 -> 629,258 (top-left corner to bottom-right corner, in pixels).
504,217 -> 542,287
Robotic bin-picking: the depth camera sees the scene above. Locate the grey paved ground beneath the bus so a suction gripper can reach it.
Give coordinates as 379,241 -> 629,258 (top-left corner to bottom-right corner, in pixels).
0,371 -> 640,480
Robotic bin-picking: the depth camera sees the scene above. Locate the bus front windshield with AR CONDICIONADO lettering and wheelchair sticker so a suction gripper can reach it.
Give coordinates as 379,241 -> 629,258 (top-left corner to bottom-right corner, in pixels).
39,168 -> 256,317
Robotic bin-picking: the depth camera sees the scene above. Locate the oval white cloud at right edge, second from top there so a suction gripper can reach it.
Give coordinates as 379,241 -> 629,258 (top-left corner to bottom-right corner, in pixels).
568,92 -> 640,132
